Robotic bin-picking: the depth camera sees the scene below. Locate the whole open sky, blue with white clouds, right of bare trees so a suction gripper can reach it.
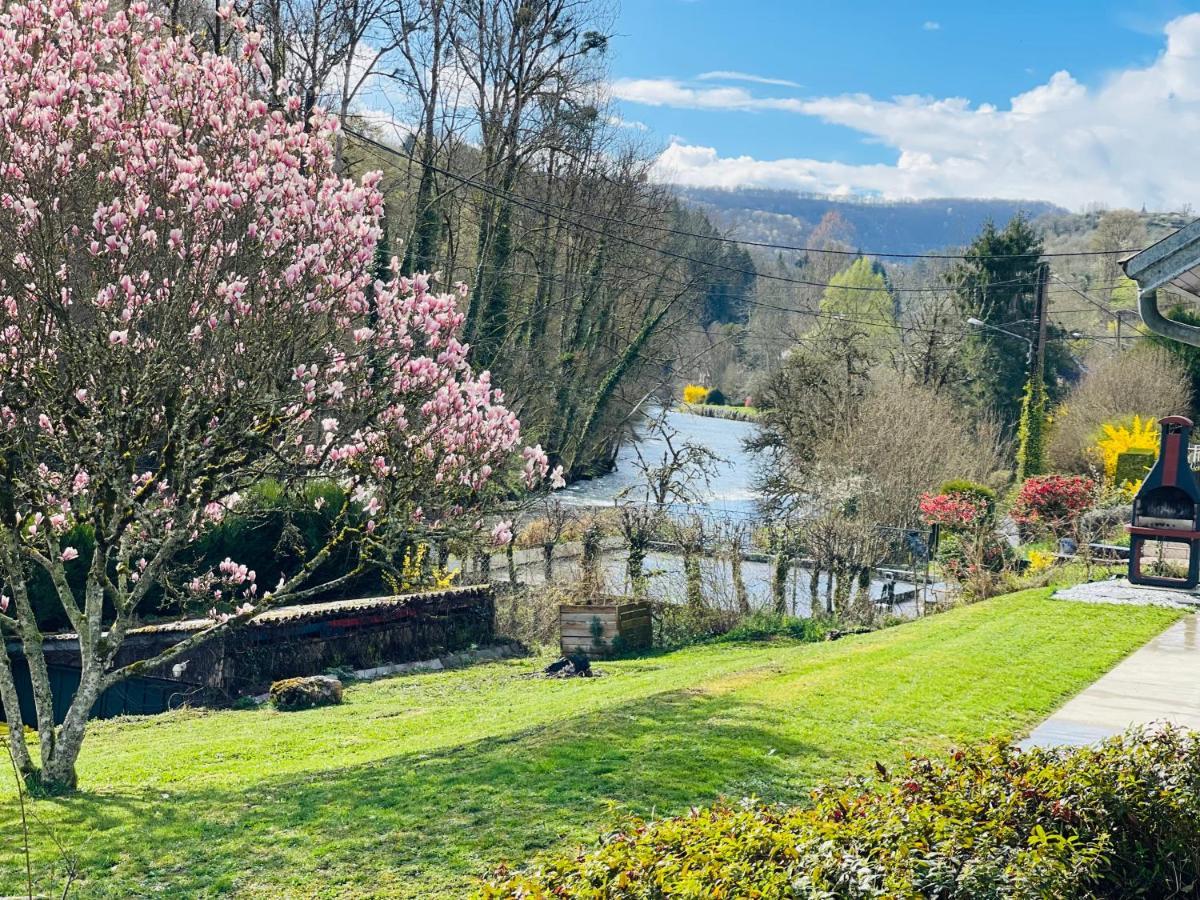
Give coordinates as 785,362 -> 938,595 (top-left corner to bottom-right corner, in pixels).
611,0 -> 1200,209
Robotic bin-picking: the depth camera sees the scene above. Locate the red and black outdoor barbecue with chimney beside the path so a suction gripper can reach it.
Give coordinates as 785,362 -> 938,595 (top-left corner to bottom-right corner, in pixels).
1126,415 -> 1200,590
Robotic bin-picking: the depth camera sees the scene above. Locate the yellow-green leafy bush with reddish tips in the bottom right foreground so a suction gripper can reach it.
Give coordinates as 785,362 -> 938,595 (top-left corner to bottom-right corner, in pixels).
479,728 -> 1200,900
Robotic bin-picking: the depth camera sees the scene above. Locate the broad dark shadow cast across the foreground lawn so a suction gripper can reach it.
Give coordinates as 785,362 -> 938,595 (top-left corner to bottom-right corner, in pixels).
16,691 -> 822,896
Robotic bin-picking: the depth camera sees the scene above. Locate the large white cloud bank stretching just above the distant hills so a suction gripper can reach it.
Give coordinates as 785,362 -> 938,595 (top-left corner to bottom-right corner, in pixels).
613,13 -> 1200,209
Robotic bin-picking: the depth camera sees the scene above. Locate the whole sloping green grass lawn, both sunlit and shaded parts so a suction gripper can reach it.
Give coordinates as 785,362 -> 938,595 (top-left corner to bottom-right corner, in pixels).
0,590 -> 1177,898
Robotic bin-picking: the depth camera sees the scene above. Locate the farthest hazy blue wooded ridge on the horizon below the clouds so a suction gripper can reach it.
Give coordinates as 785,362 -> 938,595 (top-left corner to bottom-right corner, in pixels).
678,187 -> 1069,253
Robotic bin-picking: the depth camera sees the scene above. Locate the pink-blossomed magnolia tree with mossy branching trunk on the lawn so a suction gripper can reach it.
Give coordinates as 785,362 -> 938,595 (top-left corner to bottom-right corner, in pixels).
0,0 -> 546,787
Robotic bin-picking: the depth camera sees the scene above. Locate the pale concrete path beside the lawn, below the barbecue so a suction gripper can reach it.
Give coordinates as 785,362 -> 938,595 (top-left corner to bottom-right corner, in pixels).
1021,614 -> 1200,748
